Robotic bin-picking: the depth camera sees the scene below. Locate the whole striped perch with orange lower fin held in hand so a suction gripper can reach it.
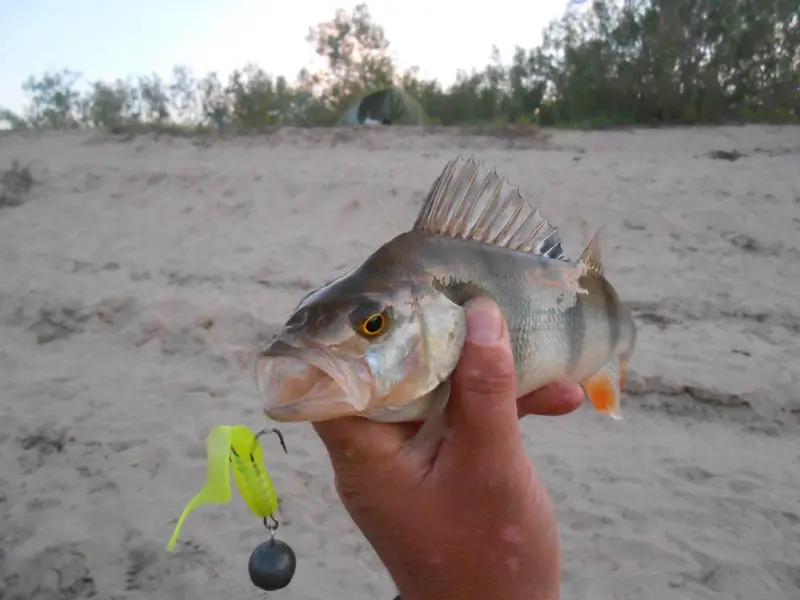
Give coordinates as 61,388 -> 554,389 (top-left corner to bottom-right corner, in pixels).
255,155 -> 636,435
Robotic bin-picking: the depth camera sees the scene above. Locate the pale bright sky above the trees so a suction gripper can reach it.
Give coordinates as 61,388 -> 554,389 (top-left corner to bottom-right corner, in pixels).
0,0 -> 567,112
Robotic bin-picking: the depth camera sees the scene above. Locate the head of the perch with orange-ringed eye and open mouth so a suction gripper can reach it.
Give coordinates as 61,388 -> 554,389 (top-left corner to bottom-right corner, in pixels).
256,270 -> 466,422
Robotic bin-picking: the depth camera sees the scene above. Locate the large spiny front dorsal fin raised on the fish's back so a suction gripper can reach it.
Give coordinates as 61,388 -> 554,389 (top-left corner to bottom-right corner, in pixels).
414,155 -> 565,259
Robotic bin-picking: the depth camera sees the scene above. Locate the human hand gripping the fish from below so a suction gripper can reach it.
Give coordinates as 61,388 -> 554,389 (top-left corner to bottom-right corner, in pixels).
314,299 -> 584,600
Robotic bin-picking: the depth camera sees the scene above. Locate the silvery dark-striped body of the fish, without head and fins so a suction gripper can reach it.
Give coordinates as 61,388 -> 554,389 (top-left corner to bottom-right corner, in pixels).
374,231 -> 636,404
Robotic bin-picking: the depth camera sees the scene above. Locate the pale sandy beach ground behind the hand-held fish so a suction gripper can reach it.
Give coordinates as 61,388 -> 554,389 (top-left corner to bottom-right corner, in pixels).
0,126 -> 800,600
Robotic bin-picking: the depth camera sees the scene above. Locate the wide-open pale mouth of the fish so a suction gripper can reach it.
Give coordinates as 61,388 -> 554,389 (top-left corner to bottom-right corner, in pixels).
256,340 -> 372,422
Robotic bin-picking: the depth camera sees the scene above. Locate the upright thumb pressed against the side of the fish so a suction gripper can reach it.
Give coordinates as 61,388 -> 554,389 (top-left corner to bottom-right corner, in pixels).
449,298 -> 521,458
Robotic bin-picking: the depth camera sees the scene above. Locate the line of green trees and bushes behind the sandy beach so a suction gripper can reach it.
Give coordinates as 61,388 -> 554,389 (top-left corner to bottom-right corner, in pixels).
0,0 -> 800,131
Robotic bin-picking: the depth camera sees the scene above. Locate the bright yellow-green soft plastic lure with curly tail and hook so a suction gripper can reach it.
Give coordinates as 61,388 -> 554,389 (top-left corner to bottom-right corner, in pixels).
167,425 -> 286,552
